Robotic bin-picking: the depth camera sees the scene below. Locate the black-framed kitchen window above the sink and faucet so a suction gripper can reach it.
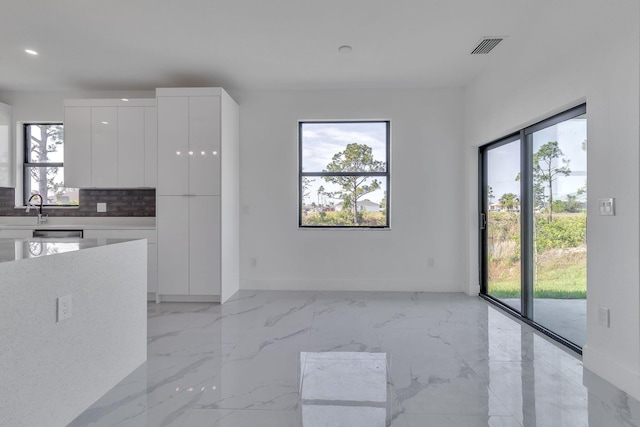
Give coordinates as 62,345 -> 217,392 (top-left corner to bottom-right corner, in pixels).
23,123 -> 78,206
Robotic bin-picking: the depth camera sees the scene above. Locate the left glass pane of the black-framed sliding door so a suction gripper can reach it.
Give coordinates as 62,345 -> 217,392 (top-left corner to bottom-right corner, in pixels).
486,139 -> 521,311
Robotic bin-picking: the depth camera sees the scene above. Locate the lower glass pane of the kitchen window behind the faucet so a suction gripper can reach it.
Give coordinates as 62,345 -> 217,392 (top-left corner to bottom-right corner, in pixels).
25,167 -> 79,205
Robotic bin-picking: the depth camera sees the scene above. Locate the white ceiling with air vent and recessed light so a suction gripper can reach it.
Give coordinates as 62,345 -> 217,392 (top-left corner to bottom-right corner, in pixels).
0,0 -> 596,91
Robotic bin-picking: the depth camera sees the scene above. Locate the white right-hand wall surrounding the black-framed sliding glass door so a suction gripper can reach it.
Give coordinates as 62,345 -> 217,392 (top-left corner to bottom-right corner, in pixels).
465,0 -> 640,398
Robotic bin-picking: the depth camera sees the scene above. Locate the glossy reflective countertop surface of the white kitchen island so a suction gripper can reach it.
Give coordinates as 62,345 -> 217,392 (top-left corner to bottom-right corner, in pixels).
0,238 -> 137,263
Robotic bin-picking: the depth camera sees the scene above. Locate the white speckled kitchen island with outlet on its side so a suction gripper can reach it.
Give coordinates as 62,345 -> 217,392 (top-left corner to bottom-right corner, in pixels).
0,239 -> 147,427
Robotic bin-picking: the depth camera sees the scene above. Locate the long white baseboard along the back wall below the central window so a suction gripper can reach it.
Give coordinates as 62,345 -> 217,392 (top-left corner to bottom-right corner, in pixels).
240,279 -> 465,292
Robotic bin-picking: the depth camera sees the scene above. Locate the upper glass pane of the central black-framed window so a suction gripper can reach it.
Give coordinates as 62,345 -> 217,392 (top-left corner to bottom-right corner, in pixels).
300,122 -> 388,172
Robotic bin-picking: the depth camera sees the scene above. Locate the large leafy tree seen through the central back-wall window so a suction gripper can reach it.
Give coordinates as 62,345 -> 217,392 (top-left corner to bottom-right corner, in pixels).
323,143 -> 385,225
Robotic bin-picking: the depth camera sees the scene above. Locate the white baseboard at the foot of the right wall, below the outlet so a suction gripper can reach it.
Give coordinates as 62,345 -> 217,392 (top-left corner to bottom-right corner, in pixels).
582,344 -> 640,400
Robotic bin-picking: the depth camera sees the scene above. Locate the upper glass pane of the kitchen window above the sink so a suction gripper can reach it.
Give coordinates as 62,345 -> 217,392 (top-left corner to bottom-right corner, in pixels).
25,124 -> 64,163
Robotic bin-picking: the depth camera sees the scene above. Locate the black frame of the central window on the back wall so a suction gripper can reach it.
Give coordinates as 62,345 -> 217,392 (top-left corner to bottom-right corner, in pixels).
298,119 -> 391,230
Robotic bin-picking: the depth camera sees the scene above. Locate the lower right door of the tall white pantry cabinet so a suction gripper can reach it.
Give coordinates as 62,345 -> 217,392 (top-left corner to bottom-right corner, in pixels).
189,196 -> 220,295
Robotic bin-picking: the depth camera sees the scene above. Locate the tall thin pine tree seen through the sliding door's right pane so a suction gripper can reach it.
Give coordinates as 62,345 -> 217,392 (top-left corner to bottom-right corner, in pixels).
533,141 -> 571,222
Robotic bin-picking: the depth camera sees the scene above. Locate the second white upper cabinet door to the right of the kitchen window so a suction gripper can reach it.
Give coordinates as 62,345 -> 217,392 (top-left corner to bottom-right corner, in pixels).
91,107 -> 118,188
